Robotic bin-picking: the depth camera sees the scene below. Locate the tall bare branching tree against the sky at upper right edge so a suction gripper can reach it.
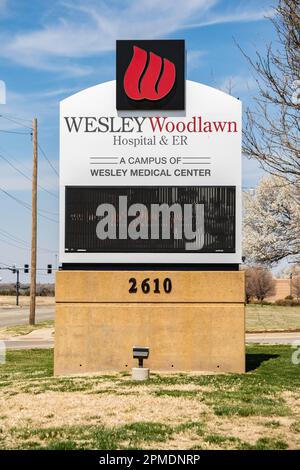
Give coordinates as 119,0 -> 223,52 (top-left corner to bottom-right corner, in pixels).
243,0 -> 300,184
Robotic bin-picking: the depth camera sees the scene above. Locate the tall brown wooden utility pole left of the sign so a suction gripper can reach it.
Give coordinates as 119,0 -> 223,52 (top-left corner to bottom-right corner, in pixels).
29,118 -> 38,325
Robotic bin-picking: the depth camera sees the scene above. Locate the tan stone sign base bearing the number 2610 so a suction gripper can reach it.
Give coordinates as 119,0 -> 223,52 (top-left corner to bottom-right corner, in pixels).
54,271 -> 245,375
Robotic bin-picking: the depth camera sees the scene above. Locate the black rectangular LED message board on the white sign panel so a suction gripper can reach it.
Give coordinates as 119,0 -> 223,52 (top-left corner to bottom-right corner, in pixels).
65,186 -> 236,253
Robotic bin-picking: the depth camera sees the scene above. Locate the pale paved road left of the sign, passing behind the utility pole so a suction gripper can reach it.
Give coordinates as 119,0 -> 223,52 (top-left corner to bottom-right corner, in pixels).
0,305 -> 54,328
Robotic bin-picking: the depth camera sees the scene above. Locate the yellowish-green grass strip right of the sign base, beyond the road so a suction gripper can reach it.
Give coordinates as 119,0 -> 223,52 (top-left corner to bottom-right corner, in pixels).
246,304 -> 300,331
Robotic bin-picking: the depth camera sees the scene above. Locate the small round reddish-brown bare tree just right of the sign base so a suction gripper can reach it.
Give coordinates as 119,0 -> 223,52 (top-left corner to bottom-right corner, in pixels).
245,267 -> 275,303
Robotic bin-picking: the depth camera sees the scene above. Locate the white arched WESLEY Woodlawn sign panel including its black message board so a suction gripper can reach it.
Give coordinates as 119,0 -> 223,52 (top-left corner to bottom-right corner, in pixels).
60,81 -> 241,264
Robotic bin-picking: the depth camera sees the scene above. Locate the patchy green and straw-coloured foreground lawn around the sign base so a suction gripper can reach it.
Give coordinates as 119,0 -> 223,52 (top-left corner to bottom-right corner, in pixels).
0,345 -> 300,449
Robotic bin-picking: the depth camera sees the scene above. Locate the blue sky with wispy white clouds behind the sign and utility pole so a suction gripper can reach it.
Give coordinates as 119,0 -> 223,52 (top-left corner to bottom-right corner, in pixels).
0,0 -> 276,282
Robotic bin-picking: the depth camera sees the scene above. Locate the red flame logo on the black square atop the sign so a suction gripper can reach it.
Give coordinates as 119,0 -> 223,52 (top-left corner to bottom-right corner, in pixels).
124,46 -> 176,101
